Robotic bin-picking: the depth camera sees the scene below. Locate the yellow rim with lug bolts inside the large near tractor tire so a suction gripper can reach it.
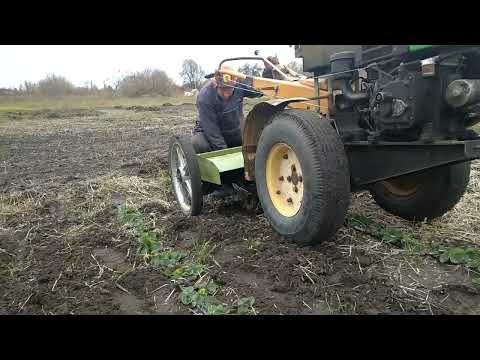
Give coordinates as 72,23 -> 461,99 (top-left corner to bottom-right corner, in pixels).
266,143 -> 304,217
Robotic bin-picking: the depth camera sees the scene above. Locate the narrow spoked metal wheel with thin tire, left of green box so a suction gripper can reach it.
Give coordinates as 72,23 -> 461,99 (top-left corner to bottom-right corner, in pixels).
169,138 -> 203,216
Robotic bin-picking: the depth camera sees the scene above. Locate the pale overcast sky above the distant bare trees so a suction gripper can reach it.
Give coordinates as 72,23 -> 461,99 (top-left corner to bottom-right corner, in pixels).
0,45 -> 299,87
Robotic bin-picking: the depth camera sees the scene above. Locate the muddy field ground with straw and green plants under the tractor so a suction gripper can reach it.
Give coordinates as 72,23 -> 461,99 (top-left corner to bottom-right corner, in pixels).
0,98 -> 480,314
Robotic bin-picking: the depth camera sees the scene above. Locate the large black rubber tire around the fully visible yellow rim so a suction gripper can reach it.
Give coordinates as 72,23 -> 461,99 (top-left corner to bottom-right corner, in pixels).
255,110 -> 350,245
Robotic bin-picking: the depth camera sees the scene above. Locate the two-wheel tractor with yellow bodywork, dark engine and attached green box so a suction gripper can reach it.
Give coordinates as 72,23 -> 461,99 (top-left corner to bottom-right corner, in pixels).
171,45 -> 480,244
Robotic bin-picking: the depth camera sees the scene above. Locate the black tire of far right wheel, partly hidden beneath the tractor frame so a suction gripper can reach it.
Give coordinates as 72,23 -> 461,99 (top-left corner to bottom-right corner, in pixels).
370,162 -> 471,221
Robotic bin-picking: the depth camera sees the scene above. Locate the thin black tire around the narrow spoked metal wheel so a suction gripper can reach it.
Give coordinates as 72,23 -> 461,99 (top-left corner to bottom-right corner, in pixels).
168,136 -> 203,216
